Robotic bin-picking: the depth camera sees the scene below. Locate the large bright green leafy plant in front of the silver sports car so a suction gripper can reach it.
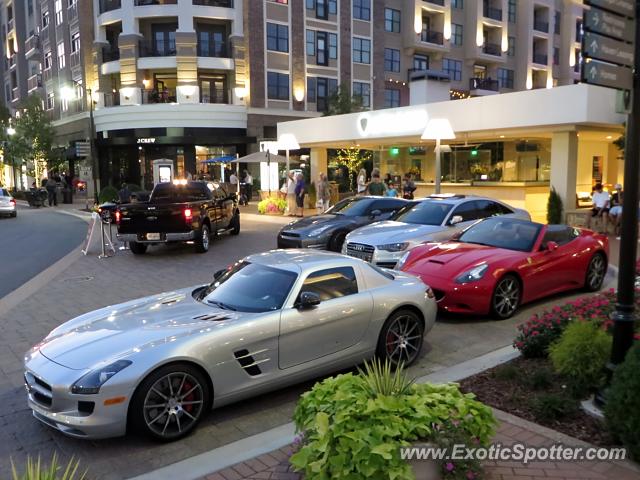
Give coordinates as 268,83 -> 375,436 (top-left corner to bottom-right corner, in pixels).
290,366 -> 496,480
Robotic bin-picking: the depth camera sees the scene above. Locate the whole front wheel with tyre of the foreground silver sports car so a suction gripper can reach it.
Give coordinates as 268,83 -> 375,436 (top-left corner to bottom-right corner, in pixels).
129,364 -> 211,442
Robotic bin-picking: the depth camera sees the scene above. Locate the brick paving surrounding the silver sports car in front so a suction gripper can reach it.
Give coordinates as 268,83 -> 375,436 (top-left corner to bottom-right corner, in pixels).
0,212 -> 620,480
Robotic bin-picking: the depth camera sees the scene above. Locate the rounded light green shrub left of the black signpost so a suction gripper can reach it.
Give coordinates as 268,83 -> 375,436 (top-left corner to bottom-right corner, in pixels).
549,322 -> 611,396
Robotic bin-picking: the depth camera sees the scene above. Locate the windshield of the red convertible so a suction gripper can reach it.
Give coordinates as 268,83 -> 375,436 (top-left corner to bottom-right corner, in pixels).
459,217 -> 542,252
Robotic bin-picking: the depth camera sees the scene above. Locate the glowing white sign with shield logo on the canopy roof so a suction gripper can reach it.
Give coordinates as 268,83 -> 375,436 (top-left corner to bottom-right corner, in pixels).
357,109 -> 429,137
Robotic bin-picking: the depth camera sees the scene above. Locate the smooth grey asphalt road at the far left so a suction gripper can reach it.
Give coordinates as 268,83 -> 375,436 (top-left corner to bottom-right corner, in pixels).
0,206 -> 87,298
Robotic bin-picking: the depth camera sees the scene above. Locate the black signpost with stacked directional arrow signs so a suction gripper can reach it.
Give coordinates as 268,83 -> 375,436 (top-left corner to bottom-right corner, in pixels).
582,0 -> 640,405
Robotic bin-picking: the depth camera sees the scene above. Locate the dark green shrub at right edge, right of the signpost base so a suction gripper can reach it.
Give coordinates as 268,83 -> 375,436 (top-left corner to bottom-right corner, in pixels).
604,342 -> 640,461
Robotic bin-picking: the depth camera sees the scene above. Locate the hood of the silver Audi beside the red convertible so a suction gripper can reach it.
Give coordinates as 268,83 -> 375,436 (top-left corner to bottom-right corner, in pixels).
347,220 -> 446,245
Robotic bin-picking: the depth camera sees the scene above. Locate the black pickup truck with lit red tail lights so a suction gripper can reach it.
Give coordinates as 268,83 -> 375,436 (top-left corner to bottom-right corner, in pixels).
114,181 -> 240,255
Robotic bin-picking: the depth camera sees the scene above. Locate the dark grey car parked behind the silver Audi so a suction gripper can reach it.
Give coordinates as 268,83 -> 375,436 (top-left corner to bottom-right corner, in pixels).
278,196 -> 410,252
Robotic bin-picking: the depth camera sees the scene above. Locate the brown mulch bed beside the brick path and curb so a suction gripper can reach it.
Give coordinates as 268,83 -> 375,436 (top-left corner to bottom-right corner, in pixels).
460,357 -> 616,446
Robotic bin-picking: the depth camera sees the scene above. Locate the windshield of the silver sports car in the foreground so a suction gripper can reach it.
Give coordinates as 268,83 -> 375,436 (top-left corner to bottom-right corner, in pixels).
200,262 -> 298,312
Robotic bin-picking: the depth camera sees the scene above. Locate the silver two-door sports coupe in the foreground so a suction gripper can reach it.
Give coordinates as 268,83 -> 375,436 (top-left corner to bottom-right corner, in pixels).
25,250 -> 436,441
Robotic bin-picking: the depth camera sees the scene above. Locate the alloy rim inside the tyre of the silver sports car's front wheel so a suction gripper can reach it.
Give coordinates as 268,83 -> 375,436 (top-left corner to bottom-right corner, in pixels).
143,372 -> 204,438
